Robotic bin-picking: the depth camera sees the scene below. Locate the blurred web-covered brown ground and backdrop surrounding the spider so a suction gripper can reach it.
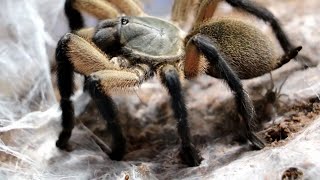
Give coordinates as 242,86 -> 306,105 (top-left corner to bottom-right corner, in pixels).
0,0 -> 320,179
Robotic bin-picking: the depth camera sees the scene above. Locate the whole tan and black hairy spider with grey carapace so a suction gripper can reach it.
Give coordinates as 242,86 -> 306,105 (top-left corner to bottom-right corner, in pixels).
56,0 -> 301,166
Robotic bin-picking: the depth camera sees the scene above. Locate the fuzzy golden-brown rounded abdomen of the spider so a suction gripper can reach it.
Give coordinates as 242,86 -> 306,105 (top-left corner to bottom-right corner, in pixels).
191,19 -> 277,79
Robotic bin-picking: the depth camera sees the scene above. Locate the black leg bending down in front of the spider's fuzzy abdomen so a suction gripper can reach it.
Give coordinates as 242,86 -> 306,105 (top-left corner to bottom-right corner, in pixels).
192,34 -> 265,149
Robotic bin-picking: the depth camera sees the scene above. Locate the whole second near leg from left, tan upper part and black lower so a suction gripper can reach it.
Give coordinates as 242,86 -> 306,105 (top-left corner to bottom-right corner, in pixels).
86,65 -> 151,160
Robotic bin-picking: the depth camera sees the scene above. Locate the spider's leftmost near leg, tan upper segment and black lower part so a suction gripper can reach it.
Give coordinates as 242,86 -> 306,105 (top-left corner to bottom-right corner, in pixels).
56,33 -> 117,150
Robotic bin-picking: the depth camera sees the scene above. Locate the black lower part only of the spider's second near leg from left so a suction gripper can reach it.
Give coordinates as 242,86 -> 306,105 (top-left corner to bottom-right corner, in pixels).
85,78 -> 126,161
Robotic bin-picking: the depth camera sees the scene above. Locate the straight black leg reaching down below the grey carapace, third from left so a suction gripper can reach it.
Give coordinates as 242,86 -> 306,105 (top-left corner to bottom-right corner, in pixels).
160,65 -> 202,166
